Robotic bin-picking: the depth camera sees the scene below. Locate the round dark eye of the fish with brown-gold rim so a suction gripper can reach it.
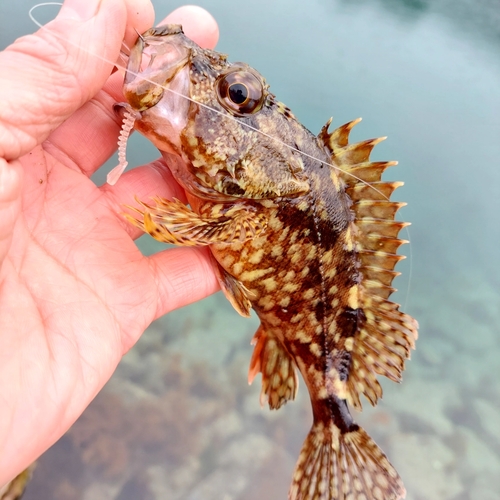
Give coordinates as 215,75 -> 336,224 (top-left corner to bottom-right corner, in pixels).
216,70 -> 264,116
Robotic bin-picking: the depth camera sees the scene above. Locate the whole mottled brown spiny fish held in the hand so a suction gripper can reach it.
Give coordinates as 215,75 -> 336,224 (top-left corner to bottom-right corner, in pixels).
119,26 -> 417,500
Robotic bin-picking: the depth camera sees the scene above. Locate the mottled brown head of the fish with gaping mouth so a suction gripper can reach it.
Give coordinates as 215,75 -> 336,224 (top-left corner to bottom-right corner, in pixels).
124,25 -> 308,199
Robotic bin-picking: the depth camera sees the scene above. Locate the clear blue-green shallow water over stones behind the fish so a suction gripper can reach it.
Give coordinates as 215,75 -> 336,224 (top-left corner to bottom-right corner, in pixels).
0,0 -> 500,500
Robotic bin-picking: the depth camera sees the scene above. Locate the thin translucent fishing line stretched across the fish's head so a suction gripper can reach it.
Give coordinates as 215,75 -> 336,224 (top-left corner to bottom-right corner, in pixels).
28,2 -> 413,308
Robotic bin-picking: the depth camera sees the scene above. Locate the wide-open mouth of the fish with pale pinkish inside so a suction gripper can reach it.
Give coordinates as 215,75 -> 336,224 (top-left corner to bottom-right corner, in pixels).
123,24 -> 191,112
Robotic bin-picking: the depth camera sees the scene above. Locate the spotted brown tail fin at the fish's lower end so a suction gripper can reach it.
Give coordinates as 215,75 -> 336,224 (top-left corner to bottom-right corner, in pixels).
288,422 -> 406,500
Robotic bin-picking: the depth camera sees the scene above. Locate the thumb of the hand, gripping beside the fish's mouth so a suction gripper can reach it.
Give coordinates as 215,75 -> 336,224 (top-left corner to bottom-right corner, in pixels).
0,0 -> 154,160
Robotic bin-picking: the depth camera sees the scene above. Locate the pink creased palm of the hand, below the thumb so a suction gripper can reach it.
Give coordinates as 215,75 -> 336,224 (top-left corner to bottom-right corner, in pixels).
0,140 -> 148,432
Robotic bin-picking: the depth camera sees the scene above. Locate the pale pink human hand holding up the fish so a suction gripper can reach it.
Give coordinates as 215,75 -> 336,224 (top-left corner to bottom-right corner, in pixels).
0,0 -> 218,485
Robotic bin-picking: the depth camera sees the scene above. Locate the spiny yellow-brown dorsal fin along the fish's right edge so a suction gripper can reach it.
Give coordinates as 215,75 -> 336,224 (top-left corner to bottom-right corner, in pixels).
318,118 -> 418,409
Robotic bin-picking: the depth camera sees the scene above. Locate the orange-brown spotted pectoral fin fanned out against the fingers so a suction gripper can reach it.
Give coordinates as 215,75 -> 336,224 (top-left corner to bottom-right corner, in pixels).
124,198 -> 266,246
